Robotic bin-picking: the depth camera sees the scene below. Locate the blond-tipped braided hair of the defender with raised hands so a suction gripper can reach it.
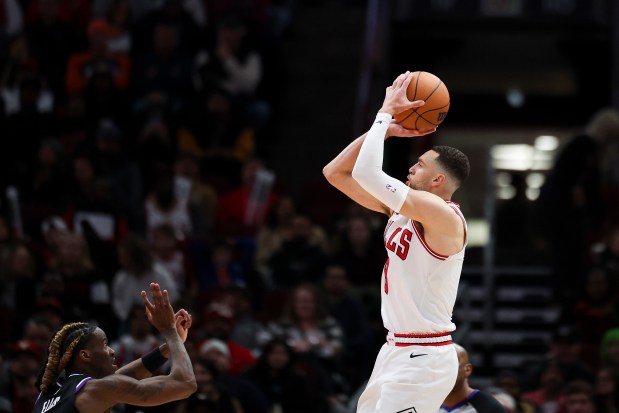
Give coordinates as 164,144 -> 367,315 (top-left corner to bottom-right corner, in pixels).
39,323 -> 96,392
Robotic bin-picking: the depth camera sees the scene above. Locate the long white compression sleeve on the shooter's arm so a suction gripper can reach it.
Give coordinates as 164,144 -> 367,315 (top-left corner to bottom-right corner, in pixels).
352,113 -> 409,212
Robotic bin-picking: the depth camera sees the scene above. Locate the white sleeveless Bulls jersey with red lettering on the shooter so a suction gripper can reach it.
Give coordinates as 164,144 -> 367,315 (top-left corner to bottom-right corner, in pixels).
381,202 -> 468,334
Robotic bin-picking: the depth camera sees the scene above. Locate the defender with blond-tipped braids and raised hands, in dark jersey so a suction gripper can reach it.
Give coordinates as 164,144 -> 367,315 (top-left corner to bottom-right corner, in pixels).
33,283 -> 196,413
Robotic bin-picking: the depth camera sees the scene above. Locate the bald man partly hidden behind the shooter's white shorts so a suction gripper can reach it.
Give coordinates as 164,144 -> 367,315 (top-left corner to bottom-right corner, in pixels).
439,344 -> 506,413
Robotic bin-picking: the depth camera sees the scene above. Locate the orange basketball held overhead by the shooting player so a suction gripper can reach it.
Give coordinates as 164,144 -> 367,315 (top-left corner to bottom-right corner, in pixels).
395,71 -> 449,131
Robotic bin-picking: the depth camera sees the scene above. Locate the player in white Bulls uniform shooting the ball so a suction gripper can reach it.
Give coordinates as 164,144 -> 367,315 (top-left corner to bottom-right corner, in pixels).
323,72 -> 470,413
